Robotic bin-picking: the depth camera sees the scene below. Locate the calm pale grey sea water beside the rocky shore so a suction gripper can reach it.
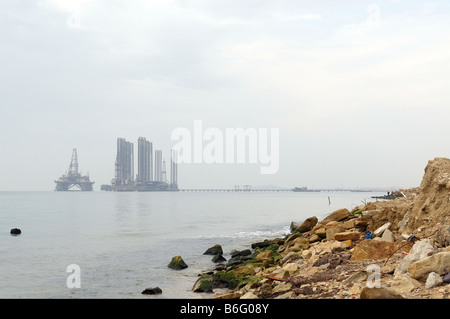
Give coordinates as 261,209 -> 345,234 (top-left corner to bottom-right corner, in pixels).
0,192 -> 379,298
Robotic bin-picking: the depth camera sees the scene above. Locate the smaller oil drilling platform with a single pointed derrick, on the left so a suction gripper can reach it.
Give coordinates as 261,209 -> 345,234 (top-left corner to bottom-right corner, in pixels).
55,148 -> 95,192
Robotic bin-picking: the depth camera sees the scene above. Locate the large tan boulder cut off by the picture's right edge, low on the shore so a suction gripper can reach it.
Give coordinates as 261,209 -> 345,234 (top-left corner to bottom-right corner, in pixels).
407,252 -> 450,280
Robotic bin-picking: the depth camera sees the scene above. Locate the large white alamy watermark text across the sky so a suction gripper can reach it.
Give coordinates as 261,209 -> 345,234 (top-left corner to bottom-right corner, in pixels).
171,120 -> 280,174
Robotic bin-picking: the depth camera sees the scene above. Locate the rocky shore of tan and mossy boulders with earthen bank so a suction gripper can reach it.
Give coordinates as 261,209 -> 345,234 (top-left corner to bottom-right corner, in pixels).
193,158 -> 450,299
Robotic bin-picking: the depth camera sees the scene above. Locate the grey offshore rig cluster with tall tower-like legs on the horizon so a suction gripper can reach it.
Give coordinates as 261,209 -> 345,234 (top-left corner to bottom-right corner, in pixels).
100,137 -> 179,192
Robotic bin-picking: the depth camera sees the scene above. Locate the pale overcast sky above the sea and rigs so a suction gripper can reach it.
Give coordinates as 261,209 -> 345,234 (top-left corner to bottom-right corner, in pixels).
0,0 -> 450,191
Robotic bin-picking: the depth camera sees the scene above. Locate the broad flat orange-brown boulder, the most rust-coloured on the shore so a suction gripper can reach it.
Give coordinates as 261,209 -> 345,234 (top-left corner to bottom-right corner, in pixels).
350,239 -> 412,261
